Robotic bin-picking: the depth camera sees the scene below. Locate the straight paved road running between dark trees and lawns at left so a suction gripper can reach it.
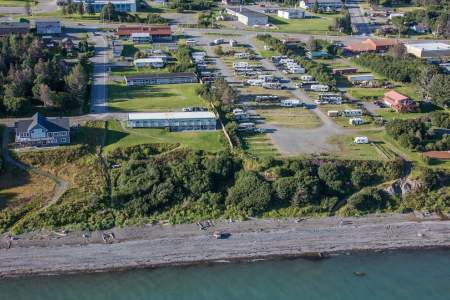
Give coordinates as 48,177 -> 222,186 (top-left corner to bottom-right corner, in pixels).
89,33 -> 111,114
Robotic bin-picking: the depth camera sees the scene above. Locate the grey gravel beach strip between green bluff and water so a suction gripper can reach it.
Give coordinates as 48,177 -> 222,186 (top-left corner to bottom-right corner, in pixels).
0,214 -> 450,278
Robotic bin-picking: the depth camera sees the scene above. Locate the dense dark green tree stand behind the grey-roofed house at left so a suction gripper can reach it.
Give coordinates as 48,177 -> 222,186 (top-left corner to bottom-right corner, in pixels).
0,35 -> 89,114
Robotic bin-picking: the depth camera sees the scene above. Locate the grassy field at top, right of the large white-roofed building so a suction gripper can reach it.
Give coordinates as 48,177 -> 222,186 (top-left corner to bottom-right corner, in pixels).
269,15 -> 341,35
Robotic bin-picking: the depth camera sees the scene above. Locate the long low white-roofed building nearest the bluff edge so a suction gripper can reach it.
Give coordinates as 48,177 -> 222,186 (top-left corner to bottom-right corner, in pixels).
128,111 -> 217,131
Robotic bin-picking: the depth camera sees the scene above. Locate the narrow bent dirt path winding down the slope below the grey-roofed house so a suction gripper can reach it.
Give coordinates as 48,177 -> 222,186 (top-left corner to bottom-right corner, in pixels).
2,127 -> 69,210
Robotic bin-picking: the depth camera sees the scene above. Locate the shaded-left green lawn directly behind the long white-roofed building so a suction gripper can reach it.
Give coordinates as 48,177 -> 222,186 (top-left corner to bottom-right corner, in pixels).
108,83 -> 207,112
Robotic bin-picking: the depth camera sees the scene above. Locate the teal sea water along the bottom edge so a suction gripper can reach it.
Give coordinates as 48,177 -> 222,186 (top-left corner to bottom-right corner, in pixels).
0,250 -> 450,300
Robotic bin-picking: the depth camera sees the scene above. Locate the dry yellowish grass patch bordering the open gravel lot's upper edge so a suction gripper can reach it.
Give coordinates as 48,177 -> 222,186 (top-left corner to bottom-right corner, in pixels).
256,107 -> 320,129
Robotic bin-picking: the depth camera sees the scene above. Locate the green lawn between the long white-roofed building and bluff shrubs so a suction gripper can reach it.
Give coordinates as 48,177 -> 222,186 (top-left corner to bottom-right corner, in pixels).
105,121 -> 225,152
